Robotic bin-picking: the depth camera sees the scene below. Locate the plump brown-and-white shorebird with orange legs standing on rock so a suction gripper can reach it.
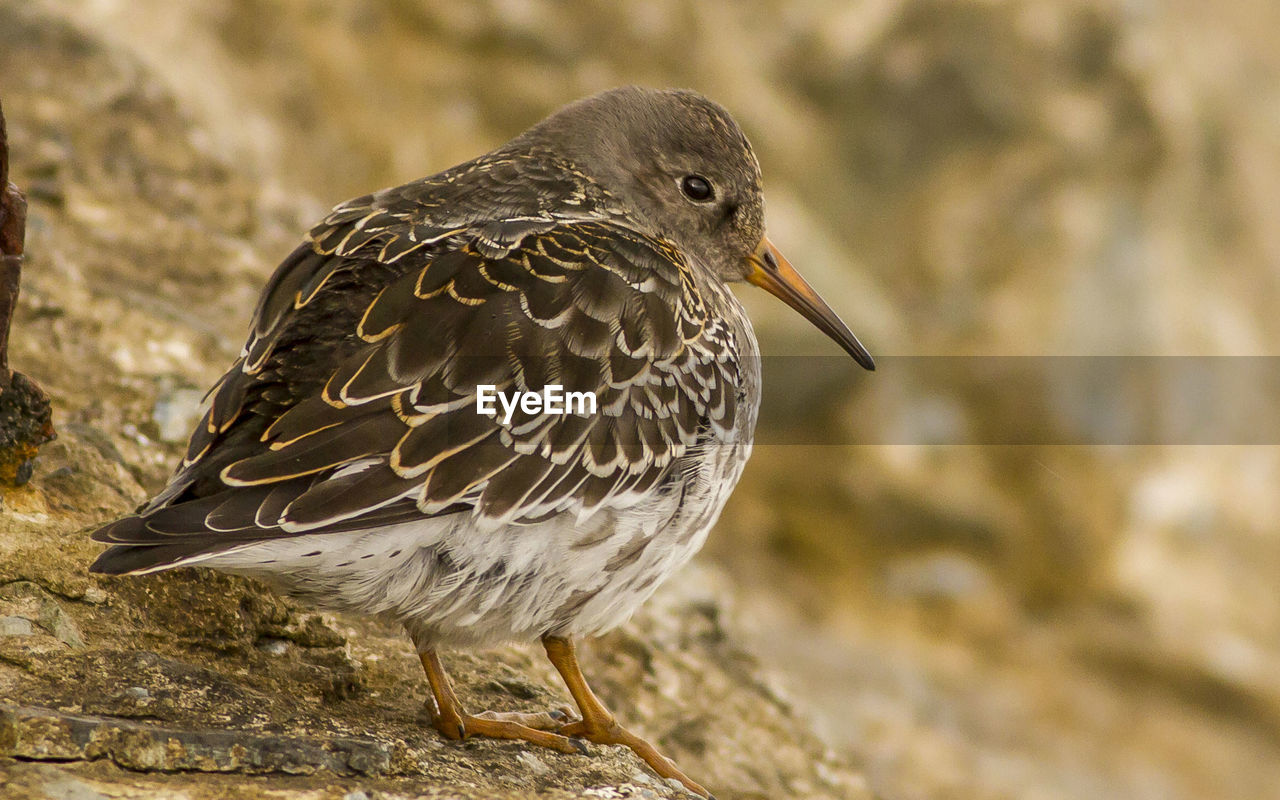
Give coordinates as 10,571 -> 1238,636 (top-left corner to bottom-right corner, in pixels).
90,87 -> 874,797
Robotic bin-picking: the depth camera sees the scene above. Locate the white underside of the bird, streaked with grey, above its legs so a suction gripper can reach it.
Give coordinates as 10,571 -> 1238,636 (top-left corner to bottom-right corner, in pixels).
200,447 -> 745,649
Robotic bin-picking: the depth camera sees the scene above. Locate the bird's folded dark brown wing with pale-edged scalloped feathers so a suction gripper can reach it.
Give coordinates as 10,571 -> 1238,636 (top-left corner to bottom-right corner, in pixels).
93,209 -> 739,560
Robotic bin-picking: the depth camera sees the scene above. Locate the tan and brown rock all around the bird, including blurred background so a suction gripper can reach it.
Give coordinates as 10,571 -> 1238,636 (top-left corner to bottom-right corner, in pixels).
0,0 -> 1280,800
